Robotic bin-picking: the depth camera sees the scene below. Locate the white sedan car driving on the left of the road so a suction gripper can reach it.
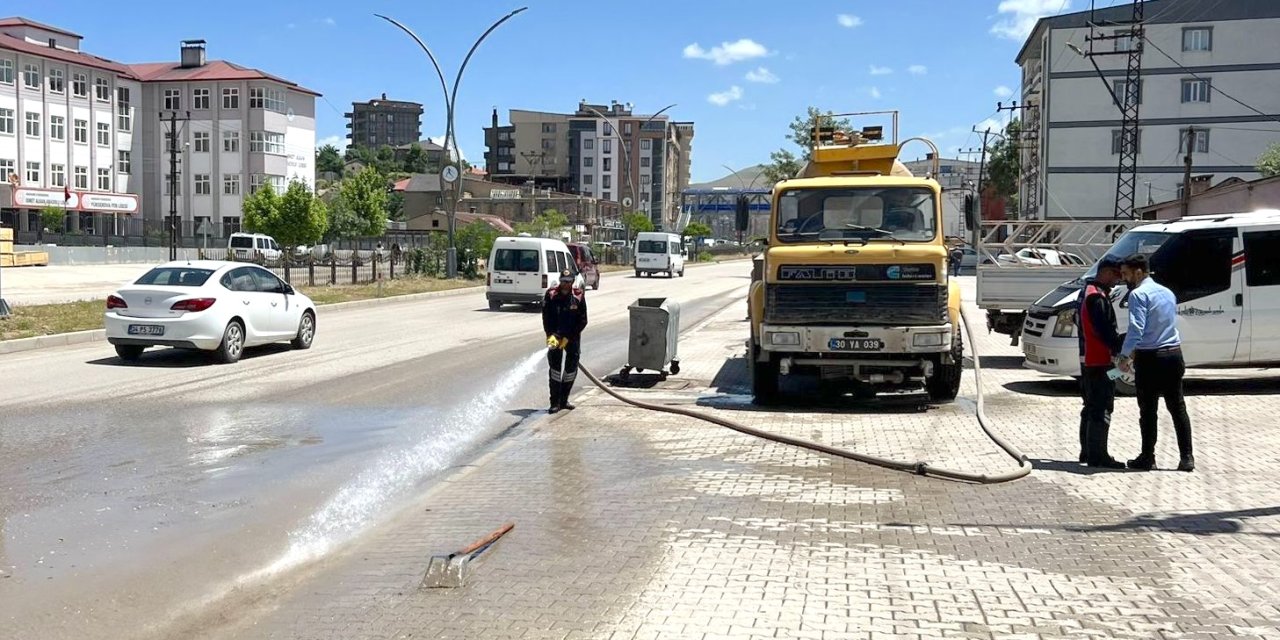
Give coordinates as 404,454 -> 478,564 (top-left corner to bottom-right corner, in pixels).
106,260 -> 316,364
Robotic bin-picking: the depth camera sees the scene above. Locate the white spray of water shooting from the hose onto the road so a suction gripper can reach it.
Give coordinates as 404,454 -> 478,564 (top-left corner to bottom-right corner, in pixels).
262,352 -> 547,573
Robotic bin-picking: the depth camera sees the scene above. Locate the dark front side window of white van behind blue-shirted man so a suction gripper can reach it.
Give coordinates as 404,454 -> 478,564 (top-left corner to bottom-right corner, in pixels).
1151,229 -> 1235,303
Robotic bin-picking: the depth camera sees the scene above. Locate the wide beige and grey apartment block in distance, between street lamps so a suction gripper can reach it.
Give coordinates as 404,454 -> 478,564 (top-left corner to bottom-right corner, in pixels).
485,101 -> 694,229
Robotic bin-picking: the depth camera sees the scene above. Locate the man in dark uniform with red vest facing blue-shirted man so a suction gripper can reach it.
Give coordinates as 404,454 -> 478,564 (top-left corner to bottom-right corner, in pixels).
1075,257 -> 1125,468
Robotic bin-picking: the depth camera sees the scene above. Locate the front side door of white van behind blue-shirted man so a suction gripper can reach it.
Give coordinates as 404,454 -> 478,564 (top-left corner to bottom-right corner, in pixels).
1151,228 -> 1244,365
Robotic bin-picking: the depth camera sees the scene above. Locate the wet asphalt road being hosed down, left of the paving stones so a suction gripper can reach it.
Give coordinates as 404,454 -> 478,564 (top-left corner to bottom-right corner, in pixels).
0,261 -> 750,639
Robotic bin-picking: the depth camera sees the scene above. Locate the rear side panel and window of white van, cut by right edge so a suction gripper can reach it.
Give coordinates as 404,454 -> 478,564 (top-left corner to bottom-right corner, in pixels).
1236,229 -> 1280,362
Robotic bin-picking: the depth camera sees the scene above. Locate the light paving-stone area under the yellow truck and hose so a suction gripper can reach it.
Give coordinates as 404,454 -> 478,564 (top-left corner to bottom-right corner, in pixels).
204,281 -> 1280,639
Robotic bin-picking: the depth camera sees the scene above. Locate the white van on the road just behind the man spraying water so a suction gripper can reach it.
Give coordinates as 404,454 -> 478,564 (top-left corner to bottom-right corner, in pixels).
485,236 -> 582,311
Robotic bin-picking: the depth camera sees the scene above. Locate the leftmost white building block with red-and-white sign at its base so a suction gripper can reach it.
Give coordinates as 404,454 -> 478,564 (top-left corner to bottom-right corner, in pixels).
0,18 -> 142,233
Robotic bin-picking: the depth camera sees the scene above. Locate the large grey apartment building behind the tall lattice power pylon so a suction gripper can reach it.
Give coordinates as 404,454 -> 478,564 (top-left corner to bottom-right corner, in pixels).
1016,0 -> 1280,219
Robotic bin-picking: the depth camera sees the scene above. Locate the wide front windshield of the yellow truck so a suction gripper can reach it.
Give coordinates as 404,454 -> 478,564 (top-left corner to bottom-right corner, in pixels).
777,187 -> 937,242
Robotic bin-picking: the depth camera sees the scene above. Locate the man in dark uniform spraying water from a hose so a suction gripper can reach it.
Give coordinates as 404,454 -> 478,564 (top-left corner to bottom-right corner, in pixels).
543,270 -> 586,413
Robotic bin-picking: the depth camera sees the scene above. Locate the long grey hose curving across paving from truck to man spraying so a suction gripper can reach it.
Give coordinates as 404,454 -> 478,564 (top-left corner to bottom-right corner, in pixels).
579,308 -> 1032,484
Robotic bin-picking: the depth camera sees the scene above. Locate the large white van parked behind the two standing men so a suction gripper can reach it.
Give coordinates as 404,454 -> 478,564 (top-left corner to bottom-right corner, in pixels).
1023,210 -> 1280,376
